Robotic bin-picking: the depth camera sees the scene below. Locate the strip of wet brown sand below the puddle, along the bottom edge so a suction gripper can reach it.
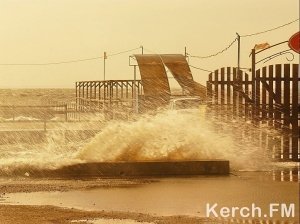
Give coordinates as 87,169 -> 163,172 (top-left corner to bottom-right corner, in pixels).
0,205 -> 211,224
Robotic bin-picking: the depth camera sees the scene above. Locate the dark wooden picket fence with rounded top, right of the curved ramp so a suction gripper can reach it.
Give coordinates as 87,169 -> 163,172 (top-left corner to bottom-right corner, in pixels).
207,64 -> 300,161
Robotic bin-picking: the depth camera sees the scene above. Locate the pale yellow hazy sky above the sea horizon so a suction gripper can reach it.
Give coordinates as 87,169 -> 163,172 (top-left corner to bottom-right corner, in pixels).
0,0 -> 299,88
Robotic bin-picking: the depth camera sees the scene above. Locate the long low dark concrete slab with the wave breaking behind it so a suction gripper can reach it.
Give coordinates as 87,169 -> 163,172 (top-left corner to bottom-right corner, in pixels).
26,160 -> 230,178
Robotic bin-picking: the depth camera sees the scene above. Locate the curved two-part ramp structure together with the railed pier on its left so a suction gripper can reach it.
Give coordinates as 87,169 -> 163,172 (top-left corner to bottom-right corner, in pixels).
76,54 -> 206,114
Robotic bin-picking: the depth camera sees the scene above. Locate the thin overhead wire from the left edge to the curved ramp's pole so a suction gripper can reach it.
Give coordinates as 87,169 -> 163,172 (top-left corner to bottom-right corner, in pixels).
0,47 -> 141,66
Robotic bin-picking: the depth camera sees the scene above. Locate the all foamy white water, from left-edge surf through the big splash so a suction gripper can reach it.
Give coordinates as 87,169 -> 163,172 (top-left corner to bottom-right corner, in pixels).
0,110 -> 276,174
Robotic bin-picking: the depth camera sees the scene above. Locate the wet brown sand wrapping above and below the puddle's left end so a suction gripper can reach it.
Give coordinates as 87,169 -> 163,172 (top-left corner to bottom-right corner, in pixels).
0,178 -> 209,224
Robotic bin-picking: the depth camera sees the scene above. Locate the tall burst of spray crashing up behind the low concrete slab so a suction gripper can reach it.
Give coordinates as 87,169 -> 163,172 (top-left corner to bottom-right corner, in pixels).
76,110 -> 274,170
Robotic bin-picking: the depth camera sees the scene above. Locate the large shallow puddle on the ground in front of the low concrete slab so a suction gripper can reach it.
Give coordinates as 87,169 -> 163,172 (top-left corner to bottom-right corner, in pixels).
3,172 -> 299,219
